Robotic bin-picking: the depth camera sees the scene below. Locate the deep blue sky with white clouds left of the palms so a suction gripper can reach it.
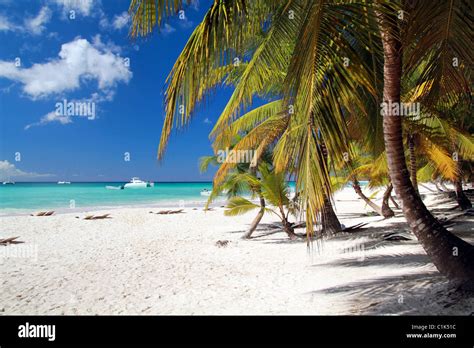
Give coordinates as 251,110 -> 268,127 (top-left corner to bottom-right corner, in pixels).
0,0 -> 231,181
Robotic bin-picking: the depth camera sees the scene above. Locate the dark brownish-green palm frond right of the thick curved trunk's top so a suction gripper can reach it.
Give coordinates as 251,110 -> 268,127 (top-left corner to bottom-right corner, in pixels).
404,0 -> 474,104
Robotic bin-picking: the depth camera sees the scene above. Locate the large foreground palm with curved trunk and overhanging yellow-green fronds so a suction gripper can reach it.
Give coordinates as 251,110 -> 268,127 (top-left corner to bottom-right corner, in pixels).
130,0 -> 474,279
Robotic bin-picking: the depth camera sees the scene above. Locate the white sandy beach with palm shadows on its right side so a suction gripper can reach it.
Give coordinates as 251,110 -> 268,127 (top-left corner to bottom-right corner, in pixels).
0,188 -> 474,315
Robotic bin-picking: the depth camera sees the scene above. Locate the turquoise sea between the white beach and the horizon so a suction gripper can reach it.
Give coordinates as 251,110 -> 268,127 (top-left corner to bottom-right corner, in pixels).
0,182 -> 366,215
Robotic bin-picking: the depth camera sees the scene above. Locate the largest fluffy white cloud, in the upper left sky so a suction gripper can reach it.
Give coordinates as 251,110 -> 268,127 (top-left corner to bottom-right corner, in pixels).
0,38 -> 132,99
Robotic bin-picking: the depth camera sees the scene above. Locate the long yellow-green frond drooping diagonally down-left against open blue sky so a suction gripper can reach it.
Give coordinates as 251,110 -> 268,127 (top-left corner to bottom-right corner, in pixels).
154,0 -> 275,159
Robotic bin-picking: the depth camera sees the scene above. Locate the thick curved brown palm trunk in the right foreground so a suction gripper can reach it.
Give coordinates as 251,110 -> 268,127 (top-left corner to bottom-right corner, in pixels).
377,12 -> 474,281
